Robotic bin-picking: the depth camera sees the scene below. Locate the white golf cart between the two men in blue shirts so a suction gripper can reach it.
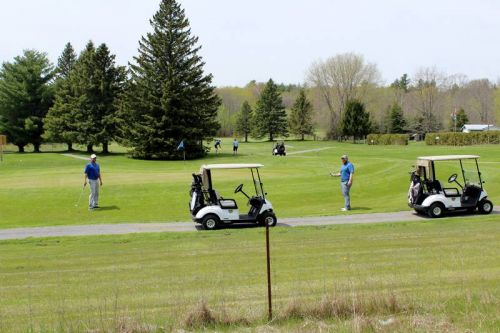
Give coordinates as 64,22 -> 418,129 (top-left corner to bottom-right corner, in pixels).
189,164 -> 277,230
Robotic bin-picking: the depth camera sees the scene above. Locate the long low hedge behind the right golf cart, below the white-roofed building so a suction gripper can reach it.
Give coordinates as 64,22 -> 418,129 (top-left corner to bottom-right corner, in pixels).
425,131 -> 500,146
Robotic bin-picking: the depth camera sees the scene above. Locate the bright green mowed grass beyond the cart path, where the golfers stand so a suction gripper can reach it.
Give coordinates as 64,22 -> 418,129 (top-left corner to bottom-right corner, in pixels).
0,139 -> 500,228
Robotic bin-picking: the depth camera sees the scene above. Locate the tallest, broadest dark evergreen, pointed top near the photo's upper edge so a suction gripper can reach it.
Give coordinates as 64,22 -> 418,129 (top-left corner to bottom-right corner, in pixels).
121,0 -> 220,159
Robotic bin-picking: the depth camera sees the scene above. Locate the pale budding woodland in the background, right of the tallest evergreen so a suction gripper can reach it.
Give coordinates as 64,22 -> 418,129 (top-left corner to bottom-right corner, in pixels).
221,58 -> 500,139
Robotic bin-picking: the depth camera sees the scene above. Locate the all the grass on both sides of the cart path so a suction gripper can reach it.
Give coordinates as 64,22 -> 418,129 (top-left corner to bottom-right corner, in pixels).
0,141 -> 500,332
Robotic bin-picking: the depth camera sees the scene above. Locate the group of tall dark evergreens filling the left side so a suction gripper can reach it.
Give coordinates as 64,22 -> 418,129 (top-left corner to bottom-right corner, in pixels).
0,0 -> 220,159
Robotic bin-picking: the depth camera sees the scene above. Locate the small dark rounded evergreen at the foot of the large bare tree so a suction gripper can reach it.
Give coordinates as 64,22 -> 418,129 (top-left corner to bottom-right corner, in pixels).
341,100 -> 371,141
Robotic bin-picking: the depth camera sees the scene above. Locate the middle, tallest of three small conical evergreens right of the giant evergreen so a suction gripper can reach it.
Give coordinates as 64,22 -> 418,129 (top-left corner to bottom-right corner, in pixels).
253,79 -> 288,141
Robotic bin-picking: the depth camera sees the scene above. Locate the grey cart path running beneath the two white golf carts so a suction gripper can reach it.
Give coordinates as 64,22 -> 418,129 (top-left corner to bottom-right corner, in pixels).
0,210 -> 500,240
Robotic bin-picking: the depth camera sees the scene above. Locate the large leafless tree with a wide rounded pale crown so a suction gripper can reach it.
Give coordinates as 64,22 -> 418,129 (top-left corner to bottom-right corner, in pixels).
307,53 -> 380,138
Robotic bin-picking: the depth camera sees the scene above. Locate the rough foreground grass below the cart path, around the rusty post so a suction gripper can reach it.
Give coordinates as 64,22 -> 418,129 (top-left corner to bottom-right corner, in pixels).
0,215 -> 500,332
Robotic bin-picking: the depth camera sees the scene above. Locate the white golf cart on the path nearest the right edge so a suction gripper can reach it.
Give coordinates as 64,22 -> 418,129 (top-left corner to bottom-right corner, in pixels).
408,155 -> 493,217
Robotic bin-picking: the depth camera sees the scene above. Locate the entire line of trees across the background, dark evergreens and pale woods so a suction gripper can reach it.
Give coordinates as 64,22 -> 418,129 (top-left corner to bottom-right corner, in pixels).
0,0 -> 500,159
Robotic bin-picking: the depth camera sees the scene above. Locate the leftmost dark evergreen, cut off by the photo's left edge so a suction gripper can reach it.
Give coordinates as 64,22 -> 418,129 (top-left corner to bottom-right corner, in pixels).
0,50 -> 54,152
